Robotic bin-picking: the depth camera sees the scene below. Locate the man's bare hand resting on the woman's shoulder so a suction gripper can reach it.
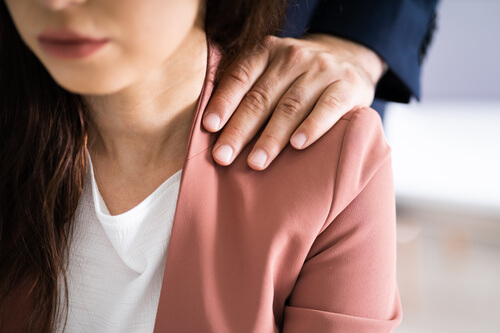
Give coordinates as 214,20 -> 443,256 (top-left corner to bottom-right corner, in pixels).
203,34 -> 386,170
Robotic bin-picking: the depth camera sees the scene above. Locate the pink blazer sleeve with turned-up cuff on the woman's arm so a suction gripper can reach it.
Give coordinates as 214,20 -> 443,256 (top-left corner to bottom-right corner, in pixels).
283,108 -> 401,333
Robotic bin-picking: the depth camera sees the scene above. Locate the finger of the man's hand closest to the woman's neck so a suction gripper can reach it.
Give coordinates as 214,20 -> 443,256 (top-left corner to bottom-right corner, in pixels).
203,46 -> 269,132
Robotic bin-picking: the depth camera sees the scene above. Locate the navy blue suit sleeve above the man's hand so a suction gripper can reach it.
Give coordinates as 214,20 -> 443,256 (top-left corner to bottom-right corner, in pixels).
282,0 -> 438,102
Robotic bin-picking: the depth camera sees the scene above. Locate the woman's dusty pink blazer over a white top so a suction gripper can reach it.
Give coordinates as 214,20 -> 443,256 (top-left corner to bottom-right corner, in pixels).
0,40 -> 401,333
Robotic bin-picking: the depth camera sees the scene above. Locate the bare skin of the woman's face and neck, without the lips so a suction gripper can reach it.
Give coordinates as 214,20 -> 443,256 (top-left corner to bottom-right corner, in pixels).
6,0 -> 207,215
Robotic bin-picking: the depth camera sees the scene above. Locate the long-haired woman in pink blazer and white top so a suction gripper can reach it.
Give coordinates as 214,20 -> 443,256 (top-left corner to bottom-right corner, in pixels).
0,0 -> 400,332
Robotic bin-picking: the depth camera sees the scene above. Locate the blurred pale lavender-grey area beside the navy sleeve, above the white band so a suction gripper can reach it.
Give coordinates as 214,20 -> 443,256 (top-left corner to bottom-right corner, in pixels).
422,0 -> 500,100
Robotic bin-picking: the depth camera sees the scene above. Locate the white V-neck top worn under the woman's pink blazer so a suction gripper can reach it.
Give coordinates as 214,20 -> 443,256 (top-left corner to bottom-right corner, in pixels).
58,158 -> 181,333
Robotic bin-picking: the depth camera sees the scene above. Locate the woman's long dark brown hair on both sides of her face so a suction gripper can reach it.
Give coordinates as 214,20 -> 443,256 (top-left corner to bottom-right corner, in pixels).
0,0 -> 286,332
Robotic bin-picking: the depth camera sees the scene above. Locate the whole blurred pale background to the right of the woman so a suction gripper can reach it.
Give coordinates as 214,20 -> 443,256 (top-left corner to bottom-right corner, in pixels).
385,0 -> 500,333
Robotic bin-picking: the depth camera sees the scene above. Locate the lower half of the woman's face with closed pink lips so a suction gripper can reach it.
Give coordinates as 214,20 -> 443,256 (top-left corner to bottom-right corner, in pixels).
5,0 -> 203,95
